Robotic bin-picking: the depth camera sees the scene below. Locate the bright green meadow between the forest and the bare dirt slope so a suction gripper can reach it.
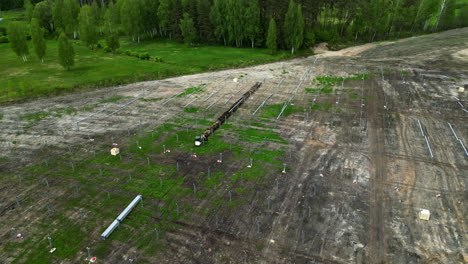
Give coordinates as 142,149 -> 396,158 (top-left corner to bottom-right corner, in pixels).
0,35 -> 308,102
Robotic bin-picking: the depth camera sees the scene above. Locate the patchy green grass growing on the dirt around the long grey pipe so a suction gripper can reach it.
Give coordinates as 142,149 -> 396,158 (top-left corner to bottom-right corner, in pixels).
0,118 -> 287,264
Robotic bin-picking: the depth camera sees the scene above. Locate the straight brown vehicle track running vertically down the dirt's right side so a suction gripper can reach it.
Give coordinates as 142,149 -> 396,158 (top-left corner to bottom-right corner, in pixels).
366,80 -> 388,264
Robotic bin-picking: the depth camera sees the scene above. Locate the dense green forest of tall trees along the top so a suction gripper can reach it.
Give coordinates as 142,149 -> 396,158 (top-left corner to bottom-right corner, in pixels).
0,0 -> 468,51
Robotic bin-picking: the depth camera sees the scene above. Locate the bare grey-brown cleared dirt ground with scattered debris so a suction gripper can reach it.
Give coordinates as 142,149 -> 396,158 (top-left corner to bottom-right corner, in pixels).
0,28 -> 468,263
